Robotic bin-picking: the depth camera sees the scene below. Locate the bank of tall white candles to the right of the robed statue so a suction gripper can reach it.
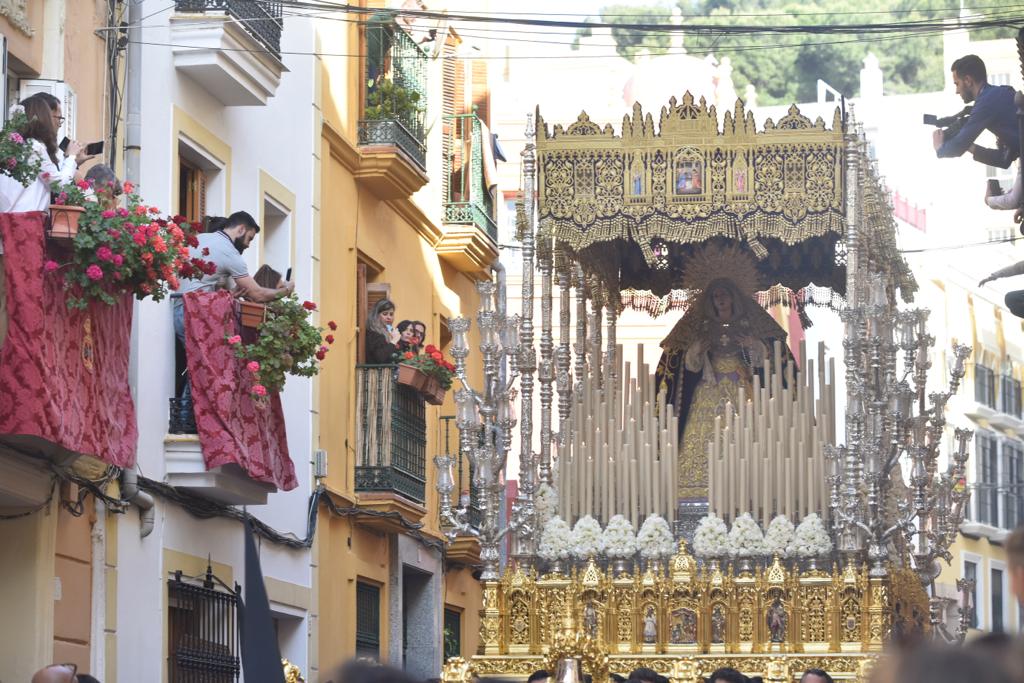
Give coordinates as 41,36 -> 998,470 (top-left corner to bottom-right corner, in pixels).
708,344 -> 836,527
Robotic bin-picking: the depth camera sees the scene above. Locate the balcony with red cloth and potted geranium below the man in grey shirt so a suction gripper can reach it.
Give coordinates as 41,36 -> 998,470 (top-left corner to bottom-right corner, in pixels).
164,290 -> 336,505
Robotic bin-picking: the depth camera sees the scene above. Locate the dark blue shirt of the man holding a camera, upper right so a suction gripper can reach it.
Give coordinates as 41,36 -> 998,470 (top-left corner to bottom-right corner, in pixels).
935,84 -> 1021,168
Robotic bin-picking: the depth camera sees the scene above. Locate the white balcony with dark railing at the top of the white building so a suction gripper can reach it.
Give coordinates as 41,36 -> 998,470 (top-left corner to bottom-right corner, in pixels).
170,0 -> 288,106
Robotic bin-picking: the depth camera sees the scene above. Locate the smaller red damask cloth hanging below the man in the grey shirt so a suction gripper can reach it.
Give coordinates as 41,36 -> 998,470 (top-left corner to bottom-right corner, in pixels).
183,291 -> 298,490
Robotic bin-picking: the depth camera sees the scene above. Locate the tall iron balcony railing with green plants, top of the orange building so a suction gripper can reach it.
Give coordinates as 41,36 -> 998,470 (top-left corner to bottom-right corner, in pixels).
358,20 -> 428,170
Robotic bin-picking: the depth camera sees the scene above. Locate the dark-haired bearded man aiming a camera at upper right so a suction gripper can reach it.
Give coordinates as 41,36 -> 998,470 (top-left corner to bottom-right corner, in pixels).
932,54 -> 1021,168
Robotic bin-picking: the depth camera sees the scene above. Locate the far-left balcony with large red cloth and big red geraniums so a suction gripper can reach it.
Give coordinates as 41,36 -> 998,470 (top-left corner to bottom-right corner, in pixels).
0,161 -> 204,507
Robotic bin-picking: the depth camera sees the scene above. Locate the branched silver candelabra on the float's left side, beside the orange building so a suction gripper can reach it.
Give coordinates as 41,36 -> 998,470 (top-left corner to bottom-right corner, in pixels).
434,282 -> 534,581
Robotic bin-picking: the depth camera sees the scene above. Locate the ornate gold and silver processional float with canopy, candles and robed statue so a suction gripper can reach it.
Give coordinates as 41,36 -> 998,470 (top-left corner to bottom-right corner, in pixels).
435,93 -> 971,683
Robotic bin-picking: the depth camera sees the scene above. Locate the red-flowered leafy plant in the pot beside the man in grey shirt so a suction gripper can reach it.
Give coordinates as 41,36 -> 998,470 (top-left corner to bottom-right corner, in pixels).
224,294 -> 338,398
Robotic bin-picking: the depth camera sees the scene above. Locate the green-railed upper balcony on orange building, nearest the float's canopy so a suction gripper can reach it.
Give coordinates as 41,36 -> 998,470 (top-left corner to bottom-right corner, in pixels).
435,114 -> 498,276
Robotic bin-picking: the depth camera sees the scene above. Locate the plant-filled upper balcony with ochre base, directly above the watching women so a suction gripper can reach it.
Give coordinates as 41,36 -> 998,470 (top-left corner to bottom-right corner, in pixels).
356,21 -> 428,199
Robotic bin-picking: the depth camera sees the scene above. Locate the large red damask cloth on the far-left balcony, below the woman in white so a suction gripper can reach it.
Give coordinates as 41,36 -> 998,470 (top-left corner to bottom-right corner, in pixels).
0,212 -> 138,468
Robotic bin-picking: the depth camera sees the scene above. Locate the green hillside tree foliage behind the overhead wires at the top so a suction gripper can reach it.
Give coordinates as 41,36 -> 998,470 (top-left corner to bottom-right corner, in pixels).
577,0 -> 974,104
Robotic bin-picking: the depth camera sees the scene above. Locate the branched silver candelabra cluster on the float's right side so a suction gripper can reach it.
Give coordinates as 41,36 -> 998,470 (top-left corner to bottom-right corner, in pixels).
825,279 -> 972,586
